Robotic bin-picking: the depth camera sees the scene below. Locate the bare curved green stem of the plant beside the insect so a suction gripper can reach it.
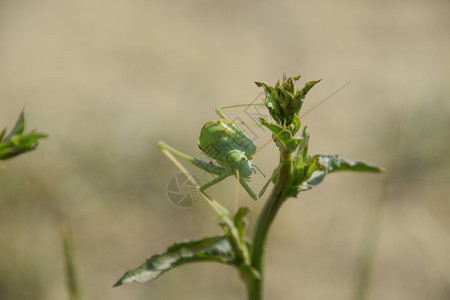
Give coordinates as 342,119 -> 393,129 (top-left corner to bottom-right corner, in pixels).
246,149 -> 292,300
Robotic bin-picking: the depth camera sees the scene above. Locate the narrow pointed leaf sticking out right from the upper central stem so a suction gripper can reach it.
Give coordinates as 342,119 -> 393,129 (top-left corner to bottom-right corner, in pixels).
315,155 -> 383,173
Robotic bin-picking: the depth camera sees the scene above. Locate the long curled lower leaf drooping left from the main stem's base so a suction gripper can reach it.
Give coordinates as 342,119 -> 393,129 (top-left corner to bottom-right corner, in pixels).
114,236 -> 234,287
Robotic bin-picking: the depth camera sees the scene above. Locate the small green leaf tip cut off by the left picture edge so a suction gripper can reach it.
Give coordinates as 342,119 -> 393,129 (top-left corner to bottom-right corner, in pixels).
0,110 -> 47,166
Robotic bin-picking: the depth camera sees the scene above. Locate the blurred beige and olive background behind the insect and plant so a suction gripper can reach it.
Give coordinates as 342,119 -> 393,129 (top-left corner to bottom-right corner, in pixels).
0,0 -> 450,300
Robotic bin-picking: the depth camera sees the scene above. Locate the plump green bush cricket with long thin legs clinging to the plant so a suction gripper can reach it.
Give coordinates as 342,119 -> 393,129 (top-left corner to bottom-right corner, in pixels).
158,104 -> 272,200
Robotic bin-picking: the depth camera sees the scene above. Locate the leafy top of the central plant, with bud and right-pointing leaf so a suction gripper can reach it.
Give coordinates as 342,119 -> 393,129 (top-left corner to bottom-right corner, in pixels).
256,75 -> 381,197
